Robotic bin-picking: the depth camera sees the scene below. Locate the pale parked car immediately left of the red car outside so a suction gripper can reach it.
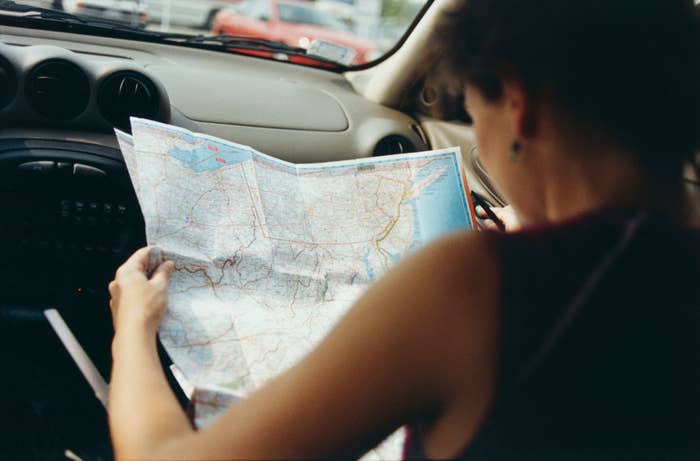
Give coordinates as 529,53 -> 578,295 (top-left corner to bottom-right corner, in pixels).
141,0 -> 240,30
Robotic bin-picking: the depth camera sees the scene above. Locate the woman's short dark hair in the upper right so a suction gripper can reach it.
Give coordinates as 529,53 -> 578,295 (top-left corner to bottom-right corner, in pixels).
439,0 -> 700,179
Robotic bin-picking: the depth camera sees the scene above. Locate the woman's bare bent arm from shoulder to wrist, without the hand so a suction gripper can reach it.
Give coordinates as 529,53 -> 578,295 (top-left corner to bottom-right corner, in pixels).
110,236 -> 499,459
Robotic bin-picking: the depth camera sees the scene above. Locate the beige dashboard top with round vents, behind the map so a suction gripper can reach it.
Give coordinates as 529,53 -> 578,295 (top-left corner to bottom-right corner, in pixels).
0,27 -> 428,162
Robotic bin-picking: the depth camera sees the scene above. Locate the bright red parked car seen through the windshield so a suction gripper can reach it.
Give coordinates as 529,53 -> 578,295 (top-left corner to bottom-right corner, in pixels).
212,0 -> 376,64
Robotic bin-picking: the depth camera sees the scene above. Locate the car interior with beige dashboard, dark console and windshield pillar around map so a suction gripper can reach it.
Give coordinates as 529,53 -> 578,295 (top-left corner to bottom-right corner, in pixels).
0,0 -> 699,460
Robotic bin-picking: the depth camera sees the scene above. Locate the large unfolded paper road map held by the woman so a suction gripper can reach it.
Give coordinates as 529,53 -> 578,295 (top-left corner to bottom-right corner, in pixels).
117,119 -> 473,457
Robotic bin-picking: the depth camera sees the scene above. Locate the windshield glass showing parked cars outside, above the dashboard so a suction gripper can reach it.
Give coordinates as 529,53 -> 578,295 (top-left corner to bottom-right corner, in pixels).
8,0 -> 427,66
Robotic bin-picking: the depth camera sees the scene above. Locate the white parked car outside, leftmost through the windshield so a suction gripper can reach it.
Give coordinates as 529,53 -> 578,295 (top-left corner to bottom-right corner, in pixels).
63,0 -> 148,27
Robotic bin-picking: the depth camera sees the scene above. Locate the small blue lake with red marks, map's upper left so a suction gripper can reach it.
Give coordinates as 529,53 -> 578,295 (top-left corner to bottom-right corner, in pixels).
168,142 -> 252,173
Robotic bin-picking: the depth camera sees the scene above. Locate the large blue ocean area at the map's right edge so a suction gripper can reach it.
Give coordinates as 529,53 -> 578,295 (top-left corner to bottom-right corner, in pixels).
411,156 -> 472,246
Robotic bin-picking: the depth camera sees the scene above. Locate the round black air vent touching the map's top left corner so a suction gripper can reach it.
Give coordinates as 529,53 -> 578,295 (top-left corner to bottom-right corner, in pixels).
98,72 -> 158,131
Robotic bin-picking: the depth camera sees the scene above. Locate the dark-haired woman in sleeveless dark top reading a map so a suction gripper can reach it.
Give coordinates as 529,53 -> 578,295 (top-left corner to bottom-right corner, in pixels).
109,0 -> 700,459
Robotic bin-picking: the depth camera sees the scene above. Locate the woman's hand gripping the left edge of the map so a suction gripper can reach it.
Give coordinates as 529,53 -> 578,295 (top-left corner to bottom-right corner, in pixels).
109,247 -> 175,334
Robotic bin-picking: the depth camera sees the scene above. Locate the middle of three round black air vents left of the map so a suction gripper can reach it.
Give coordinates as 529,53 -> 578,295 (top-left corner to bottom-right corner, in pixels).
26,59 -> 90,121
